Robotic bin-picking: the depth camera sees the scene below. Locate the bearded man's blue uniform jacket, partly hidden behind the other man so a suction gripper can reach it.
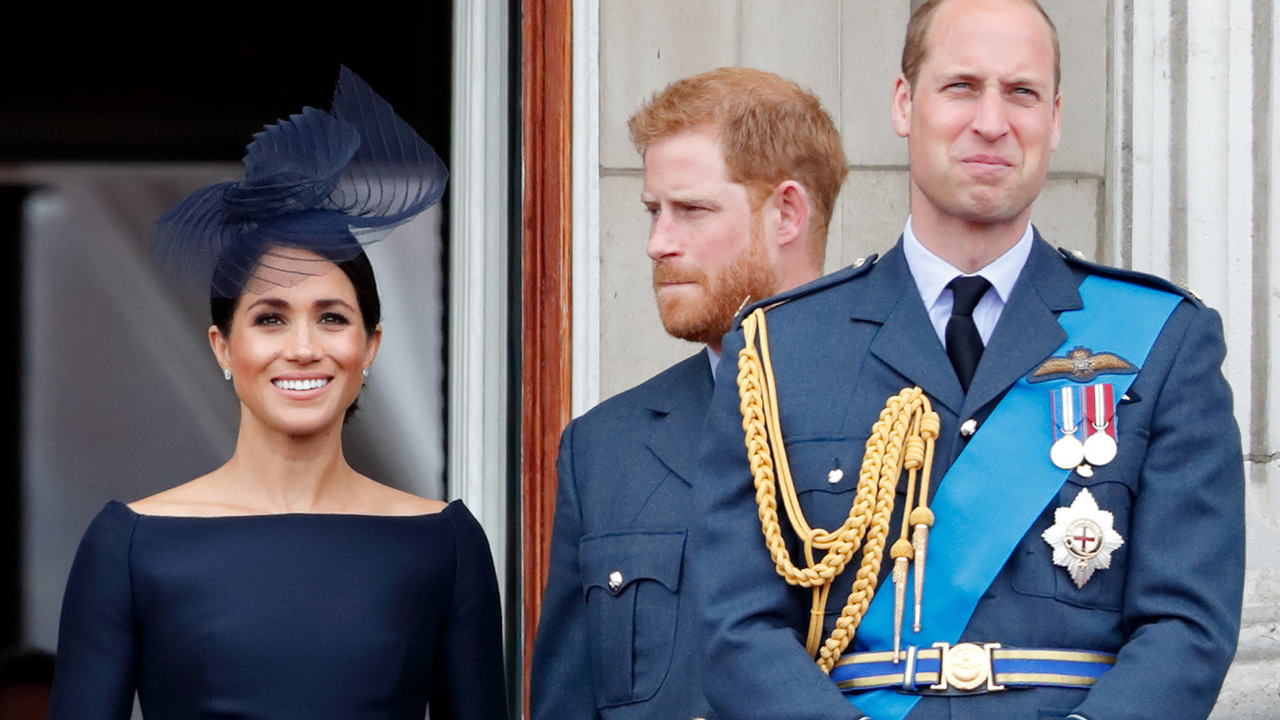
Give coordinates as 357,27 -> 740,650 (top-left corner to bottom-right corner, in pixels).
532,352 -> 712,720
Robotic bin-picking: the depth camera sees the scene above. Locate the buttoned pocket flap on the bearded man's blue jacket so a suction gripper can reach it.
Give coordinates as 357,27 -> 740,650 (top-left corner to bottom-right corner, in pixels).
579,530 -> 685,594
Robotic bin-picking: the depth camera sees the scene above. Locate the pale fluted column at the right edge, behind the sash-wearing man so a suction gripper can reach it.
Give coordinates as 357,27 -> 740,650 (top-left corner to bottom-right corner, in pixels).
1131,0 -> 1280,720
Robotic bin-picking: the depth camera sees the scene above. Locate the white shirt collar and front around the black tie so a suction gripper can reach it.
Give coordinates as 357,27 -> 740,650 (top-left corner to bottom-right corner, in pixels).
902,217 -> 1036,346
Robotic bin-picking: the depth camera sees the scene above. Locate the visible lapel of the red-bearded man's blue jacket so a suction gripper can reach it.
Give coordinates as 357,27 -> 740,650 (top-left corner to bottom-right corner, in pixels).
646,354 -> 714,484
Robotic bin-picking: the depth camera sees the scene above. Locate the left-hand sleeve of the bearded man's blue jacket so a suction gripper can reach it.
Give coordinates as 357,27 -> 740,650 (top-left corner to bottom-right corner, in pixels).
531,423 -> 598,720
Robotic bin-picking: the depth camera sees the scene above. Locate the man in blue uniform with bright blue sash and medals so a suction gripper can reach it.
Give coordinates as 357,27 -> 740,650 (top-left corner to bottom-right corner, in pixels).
690,0 -> 1244,720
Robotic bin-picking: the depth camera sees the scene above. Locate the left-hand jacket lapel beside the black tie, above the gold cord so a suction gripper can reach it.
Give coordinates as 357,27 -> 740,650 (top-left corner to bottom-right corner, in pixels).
852,241 -> 962,413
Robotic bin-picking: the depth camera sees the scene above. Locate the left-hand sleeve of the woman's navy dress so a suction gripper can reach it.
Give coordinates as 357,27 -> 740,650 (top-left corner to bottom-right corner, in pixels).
50,502 -> 138,720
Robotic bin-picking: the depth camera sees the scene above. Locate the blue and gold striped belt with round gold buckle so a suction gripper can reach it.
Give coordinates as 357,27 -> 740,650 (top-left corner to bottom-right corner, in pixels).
831,642 -> 1116,696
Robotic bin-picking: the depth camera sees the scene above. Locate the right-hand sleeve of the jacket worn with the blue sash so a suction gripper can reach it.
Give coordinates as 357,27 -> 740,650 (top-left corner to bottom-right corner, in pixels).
1075,302 -> 1244,720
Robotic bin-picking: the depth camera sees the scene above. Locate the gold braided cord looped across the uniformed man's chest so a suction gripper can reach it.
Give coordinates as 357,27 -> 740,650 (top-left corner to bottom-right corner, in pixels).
737,309 -> 938,674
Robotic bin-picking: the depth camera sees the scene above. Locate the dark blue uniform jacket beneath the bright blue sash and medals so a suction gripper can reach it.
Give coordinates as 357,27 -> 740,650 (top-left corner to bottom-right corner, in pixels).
691,237 -> 1244,720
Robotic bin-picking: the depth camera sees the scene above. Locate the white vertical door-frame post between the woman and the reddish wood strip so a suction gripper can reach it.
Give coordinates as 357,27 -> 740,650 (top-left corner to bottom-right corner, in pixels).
448,0 -> 509,589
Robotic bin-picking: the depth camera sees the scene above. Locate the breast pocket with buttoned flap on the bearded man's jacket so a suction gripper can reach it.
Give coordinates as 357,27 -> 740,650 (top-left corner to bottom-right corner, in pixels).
579,530 -> 685,707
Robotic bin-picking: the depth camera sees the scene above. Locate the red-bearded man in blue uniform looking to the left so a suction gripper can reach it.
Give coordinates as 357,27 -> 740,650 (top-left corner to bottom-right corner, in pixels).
531,68 -> 847,720
